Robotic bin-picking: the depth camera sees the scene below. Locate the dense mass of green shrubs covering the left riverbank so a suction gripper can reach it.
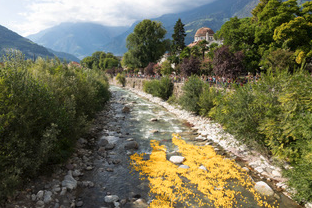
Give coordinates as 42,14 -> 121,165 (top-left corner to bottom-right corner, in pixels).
0,54 -> 110,202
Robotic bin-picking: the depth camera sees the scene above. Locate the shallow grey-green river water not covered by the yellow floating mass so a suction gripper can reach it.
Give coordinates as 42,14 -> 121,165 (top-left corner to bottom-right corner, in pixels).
77,86 -> 297,208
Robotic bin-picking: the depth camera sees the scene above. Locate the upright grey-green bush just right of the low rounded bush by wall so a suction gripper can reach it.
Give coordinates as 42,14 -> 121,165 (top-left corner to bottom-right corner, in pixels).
179,75 -> 204,114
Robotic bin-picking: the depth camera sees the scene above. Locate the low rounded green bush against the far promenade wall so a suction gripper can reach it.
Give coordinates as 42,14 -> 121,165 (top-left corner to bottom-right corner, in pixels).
143,76 -> 173,100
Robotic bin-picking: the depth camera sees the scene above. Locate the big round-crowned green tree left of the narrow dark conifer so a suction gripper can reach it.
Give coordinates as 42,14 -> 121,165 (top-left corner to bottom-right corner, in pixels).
124,19 -> 169,68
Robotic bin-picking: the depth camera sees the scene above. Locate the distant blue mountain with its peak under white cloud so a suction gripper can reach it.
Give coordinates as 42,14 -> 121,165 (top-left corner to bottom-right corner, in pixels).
27,22 -> 128,59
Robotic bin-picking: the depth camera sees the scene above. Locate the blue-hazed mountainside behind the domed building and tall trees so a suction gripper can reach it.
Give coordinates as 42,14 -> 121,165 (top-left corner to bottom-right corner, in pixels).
103,0 -> 259,55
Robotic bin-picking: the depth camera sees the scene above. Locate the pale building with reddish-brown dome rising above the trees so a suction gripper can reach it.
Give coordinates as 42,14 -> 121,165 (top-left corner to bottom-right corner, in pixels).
188,27 -> 223,47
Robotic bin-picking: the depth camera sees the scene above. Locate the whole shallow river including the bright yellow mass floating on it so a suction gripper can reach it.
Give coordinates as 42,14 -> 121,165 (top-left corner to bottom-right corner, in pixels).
77,86 -> 297,208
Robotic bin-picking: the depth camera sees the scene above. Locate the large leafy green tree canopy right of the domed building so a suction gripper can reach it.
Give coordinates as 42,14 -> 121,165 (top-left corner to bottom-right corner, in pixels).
216,0 -> 312,73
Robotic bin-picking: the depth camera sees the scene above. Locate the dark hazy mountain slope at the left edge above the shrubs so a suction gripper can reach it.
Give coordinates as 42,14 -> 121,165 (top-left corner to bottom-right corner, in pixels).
0,25 -> 80,62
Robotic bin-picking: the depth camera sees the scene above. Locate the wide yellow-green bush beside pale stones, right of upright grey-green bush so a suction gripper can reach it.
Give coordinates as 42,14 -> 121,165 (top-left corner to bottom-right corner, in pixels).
209,85 -> 264,148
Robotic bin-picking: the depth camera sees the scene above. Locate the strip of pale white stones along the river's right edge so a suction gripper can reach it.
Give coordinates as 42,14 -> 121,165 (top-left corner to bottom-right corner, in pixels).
111,78 -> 312,208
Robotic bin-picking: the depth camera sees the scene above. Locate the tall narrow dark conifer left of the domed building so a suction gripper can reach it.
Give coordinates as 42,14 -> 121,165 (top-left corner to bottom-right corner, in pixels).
171,18 -> 186,54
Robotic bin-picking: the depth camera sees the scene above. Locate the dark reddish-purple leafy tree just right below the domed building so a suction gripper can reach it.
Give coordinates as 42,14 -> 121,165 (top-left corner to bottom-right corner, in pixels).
212,46 -> 244,79
